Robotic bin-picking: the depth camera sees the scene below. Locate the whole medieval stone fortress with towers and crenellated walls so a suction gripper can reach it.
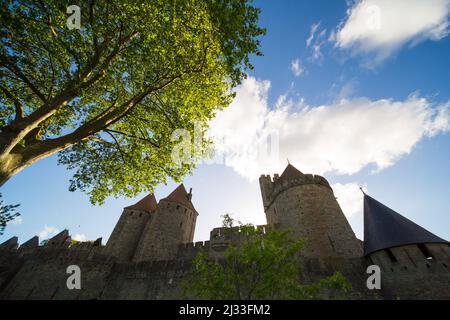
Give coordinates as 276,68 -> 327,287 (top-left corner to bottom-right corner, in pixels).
0,165 -> 450,299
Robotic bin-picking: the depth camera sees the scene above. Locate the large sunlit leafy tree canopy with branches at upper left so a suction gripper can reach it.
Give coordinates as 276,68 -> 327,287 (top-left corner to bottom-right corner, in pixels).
0,0 -> 265,203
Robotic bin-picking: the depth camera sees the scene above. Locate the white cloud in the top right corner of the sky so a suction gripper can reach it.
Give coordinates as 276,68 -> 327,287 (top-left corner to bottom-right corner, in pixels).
332,0 -> 450,64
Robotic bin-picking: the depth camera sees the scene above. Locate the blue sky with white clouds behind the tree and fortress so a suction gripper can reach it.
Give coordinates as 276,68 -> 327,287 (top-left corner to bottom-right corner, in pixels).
0,0 -> 450,243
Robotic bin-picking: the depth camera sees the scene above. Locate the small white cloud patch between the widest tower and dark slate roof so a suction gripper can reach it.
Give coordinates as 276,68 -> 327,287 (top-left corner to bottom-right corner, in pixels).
331,182 -> 367,218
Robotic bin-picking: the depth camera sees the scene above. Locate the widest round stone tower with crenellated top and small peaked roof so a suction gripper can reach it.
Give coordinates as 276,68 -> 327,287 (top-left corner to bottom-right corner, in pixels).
259,164 -> 362,257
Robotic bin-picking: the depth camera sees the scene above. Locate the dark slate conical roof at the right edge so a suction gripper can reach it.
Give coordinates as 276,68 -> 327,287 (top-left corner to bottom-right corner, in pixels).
364,194 -> 449,255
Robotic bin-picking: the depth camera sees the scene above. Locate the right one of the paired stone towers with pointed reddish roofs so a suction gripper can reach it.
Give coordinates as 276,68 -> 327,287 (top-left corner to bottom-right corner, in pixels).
134,184 -> 198,261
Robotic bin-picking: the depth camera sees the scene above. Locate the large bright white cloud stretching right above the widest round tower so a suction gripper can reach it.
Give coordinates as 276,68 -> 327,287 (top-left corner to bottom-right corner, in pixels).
210,77 -> 450,180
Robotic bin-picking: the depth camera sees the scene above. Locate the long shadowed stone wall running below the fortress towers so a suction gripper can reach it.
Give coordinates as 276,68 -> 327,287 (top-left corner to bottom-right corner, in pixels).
0,234 -> 450,299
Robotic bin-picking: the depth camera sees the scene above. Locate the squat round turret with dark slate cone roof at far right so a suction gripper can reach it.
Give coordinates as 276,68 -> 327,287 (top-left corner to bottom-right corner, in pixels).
364,194 -> 450,299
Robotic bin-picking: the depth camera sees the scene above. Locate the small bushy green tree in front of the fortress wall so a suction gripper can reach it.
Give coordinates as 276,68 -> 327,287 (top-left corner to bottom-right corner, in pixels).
184,215 -> 351,300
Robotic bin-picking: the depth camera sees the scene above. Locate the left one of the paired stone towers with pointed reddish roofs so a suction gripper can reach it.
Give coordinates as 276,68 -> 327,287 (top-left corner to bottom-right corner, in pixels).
105,194 -> 157,261
